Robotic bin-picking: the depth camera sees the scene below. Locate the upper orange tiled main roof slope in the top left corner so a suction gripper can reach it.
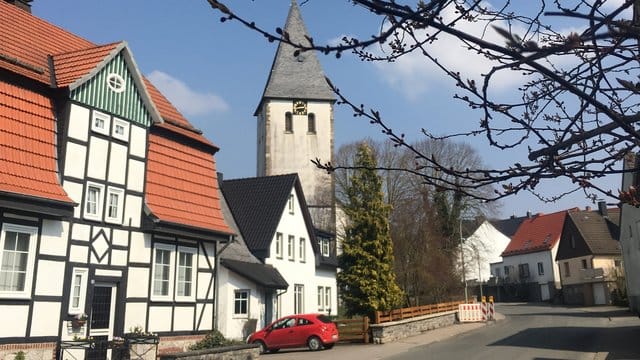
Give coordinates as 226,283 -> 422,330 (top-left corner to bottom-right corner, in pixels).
0,1 -> 95,84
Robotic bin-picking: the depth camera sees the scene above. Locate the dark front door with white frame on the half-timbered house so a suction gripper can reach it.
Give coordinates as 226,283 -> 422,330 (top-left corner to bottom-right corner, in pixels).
87,283 -> 117,360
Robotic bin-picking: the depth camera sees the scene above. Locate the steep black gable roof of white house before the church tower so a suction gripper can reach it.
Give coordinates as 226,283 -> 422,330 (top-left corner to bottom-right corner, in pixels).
221,174 -> 318,260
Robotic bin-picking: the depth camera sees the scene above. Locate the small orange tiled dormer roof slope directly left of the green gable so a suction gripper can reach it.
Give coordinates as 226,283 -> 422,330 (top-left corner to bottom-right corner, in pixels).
53,43 -> 121,87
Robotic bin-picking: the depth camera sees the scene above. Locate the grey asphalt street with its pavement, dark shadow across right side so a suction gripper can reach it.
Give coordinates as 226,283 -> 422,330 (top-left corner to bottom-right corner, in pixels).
261,304 -> 640,360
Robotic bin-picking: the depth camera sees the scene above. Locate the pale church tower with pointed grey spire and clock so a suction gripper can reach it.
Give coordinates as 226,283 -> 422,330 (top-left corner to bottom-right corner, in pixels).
254,0 -> 336,232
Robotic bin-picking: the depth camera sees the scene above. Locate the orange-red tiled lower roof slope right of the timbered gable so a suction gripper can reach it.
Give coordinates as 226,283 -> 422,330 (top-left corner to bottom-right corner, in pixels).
145,133 -> 232,234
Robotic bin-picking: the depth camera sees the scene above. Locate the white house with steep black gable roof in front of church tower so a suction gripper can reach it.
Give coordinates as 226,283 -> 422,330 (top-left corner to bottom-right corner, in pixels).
221,174 -> 337,323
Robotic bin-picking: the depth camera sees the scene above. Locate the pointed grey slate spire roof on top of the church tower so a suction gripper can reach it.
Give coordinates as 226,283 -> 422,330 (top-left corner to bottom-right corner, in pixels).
254,1 -> 335,115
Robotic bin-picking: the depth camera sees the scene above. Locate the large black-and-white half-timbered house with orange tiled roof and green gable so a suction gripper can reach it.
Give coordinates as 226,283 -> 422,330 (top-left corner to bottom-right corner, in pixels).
0,1 -> 233,359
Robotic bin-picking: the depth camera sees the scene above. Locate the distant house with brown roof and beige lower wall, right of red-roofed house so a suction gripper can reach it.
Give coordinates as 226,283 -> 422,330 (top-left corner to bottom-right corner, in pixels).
556,202 -> 624,305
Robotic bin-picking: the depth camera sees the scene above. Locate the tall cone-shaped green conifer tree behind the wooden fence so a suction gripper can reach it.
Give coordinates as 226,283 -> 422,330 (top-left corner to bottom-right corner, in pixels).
338,143 -> 403,316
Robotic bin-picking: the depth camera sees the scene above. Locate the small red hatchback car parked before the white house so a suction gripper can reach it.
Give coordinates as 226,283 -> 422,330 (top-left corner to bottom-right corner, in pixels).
247,314 -> 338,353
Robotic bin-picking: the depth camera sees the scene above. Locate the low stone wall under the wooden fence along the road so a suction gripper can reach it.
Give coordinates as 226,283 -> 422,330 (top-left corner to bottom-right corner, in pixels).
370,311 -> 458,344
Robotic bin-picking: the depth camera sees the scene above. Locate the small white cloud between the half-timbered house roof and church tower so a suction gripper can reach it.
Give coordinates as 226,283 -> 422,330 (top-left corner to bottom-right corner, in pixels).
147,70 -> 229,116
